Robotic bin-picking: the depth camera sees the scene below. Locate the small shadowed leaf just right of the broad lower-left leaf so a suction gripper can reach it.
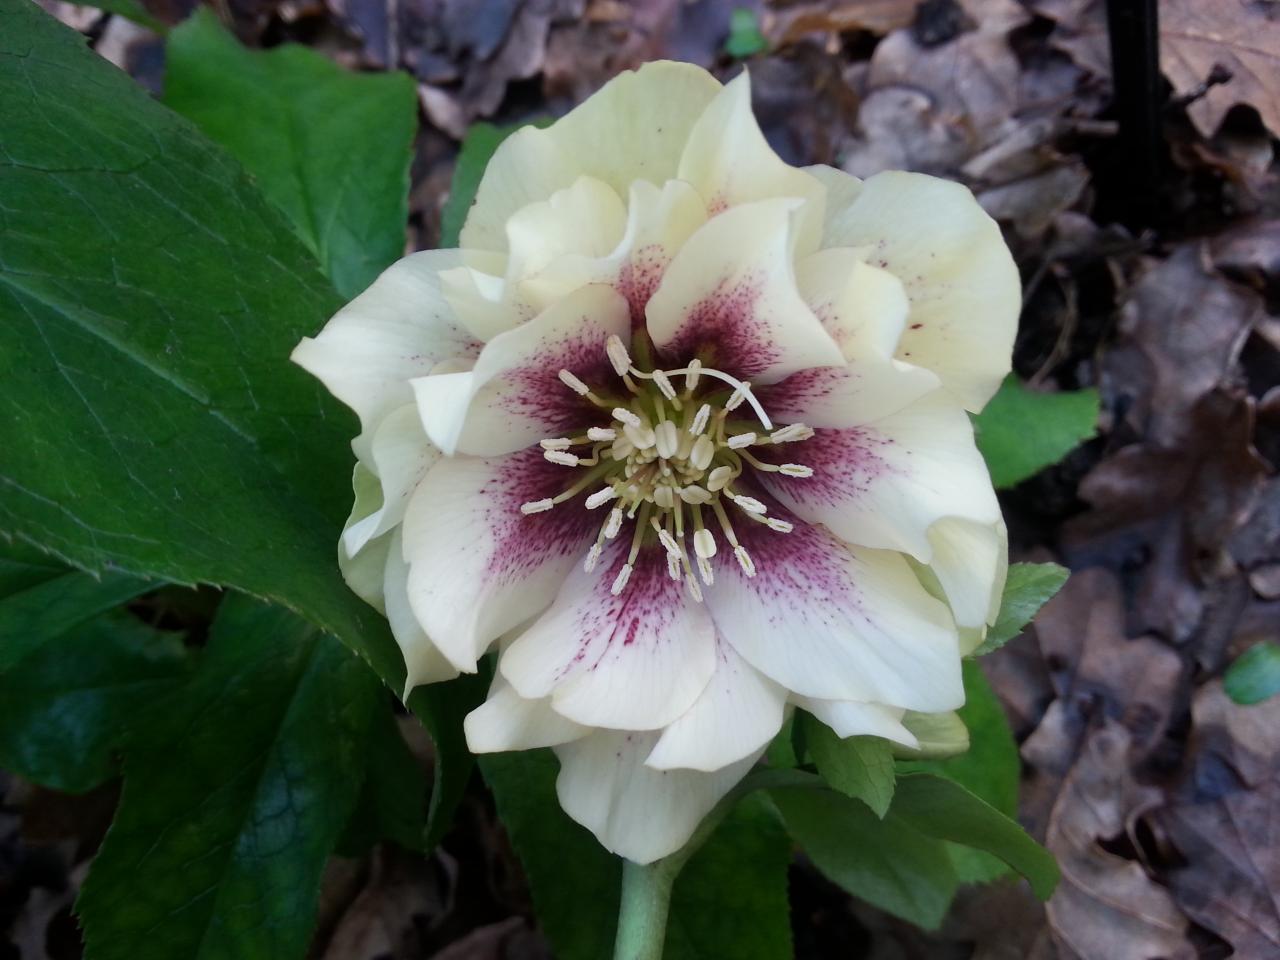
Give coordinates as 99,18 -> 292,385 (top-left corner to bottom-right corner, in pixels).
338,698 -> 426,856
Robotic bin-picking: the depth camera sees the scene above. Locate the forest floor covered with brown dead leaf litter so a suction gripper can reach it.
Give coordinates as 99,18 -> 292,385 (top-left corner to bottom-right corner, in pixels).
10,0 -> 1280,960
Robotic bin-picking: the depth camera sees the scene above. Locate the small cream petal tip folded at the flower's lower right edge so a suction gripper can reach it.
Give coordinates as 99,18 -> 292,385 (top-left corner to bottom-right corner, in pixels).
929,517 -> 1009,627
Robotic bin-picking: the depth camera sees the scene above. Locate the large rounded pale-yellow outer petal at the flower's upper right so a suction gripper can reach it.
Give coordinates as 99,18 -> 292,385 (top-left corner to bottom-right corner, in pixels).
827,172 -> 1021,412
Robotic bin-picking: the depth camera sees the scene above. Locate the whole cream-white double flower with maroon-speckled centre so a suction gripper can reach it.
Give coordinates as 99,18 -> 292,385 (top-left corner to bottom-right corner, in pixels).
293,63 -> 1019,863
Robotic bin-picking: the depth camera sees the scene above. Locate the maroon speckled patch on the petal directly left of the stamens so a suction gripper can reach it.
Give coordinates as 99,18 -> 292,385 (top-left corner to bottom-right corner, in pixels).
480,447 -> 603,584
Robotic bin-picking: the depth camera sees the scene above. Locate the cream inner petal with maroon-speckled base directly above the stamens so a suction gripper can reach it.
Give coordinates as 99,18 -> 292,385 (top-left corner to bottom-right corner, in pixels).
646,200 -> 845,383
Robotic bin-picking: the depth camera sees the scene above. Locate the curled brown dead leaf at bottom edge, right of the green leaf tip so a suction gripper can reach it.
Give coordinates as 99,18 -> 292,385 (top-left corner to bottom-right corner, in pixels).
1046,721 -> 1196,960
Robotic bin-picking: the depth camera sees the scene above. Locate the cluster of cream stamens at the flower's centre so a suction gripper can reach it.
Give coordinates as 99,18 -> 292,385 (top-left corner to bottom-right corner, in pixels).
520,337 -> 813,600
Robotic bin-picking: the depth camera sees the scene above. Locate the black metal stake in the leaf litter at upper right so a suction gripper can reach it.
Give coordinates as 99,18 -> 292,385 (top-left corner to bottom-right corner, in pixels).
1107,0 -> 1164,225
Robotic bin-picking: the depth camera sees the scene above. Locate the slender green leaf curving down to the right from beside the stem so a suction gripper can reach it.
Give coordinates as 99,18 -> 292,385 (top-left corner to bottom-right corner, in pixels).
893,773 -> 1059,900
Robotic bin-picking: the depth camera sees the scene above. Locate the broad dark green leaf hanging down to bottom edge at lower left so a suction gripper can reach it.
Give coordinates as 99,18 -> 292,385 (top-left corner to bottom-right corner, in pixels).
77,595 -> 380,960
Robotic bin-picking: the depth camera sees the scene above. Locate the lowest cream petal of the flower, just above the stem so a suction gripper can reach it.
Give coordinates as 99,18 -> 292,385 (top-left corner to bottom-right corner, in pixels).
556,730 -> 758,864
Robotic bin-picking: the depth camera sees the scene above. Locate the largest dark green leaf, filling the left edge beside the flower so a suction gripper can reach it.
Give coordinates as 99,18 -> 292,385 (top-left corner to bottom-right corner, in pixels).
0,0 -> 403,689
